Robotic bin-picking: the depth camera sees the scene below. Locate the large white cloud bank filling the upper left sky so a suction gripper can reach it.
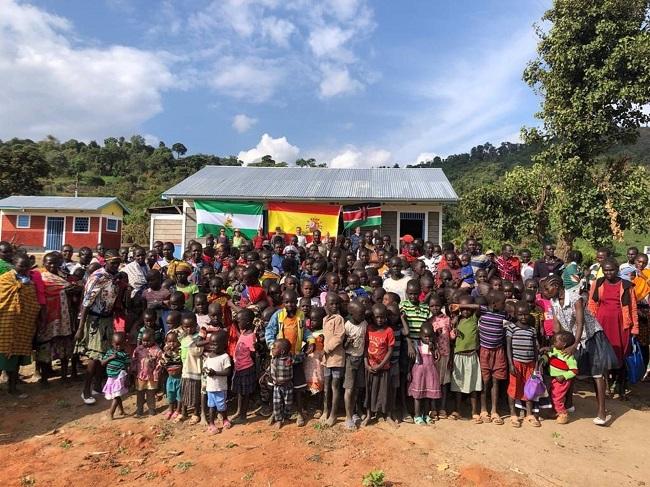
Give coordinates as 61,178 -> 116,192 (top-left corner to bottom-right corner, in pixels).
0,0 -> 175,140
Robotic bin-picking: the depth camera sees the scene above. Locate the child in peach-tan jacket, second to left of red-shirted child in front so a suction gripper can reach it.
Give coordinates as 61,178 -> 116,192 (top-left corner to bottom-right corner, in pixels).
321,292 -> 345,426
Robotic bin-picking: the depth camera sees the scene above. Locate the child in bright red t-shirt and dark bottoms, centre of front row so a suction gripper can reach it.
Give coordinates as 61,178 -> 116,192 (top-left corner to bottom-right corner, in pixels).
361,304 -> 395,426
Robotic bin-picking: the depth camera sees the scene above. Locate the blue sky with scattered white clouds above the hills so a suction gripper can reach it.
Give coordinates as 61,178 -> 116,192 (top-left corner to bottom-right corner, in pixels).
0,0 -> 550,168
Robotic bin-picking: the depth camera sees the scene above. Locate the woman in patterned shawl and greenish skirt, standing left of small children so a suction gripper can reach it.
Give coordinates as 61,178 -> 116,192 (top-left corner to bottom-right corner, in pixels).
75,250 -> 121,404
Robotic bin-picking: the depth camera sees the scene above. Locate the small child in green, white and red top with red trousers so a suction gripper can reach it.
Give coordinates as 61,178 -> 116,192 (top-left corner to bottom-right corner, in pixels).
548,331 -> 578,424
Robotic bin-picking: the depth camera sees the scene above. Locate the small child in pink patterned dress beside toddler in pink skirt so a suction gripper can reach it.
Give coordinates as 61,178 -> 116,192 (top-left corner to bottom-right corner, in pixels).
133,329 -> 162,417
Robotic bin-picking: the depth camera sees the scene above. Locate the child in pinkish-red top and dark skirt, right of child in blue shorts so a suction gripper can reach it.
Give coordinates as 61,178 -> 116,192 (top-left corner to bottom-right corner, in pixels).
232,309 -> 257,423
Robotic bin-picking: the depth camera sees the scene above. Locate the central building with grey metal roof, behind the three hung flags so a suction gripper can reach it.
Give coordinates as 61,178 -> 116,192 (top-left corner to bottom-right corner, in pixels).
158,166 -> 458,248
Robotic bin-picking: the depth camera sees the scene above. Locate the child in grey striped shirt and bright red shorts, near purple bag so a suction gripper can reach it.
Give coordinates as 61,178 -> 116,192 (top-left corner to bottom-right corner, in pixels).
506,301 -> 541,428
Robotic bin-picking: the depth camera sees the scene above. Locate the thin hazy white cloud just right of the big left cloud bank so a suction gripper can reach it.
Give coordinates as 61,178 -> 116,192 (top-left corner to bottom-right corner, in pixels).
210,58 -> 285,102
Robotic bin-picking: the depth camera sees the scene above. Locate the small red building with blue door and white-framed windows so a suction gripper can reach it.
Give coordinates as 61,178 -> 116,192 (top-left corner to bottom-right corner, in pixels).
0,196 -> 129,252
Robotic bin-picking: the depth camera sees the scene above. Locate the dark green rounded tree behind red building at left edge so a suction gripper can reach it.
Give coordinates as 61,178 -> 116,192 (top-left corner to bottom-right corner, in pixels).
0,142 -> 50,198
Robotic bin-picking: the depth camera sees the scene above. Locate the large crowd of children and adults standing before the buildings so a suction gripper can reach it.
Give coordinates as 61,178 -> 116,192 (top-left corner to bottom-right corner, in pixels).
0,228 -> 650,434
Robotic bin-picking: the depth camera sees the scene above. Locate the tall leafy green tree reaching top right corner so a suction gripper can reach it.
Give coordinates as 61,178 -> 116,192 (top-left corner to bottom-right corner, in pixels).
523,0 -> 650,254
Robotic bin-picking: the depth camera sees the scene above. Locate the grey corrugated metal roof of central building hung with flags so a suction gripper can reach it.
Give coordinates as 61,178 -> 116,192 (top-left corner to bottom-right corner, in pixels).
162,166 -> 458,202
